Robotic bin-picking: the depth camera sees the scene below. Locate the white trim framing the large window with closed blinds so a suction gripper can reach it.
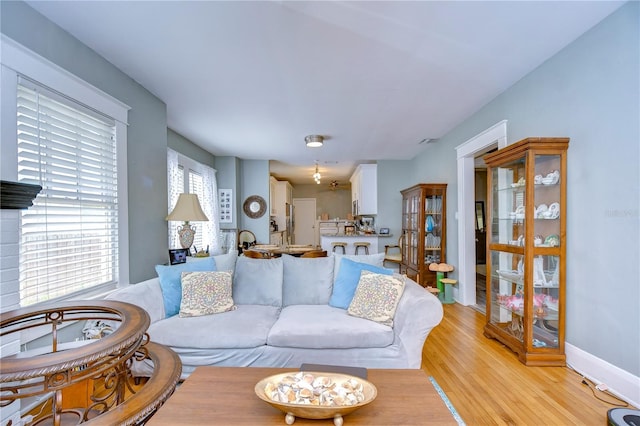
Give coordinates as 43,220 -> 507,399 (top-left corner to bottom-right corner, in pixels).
0,34 -> 131,292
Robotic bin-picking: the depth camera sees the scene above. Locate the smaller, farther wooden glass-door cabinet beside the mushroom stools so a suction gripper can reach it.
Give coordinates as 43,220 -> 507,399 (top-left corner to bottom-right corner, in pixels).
400,183 -> 447,287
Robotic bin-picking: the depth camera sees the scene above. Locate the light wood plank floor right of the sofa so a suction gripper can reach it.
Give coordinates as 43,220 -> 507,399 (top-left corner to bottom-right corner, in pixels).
422,304 -> 632,426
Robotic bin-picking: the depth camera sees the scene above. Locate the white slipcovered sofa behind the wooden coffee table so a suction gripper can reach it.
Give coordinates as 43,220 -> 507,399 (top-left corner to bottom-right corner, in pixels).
109,252 -> 443,377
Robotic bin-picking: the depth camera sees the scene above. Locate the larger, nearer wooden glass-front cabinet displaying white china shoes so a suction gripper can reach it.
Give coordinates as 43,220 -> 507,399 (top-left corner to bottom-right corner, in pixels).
484,138 -> 569,366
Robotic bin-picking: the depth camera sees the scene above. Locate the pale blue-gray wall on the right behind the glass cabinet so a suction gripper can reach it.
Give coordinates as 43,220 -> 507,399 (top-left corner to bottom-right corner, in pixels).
398,2 -> 640,376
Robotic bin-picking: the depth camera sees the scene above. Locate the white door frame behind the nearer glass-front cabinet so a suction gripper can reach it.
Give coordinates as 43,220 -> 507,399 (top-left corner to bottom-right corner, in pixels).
453,120 -> 507,306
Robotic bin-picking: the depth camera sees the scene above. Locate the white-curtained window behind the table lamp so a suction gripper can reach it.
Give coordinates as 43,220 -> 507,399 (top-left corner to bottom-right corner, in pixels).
167,149 -> 221,253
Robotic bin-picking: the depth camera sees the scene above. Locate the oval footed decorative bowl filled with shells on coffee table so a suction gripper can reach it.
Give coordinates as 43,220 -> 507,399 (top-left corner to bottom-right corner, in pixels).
255,371 -> 378,426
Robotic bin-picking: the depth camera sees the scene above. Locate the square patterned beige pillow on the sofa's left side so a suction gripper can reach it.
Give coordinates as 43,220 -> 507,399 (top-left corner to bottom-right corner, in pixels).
180,271 -> 236,317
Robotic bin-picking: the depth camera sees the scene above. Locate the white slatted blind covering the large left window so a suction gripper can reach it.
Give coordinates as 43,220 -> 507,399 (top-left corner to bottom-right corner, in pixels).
17,80 -> 118,306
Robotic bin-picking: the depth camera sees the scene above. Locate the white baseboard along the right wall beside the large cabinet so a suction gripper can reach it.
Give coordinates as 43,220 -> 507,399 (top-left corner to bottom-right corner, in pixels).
565,343 -> 640,408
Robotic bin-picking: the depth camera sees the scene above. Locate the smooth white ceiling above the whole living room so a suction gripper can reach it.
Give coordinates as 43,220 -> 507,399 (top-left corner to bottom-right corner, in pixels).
27,1 -> 623,183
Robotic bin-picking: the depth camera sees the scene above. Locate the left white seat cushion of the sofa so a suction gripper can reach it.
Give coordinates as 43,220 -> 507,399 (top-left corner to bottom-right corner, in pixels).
148,305 -> 282,349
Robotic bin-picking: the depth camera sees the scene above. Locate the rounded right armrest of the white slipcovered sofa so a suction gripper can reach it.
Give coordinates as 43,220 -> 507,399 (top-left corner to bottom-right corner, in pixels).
393,278 -> 444,368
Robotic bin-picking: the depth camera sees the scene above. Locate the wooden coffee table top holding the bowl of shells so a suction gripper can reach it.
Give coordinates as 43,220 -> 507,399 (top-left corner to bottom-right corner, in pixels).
147,367 -> 457,426
